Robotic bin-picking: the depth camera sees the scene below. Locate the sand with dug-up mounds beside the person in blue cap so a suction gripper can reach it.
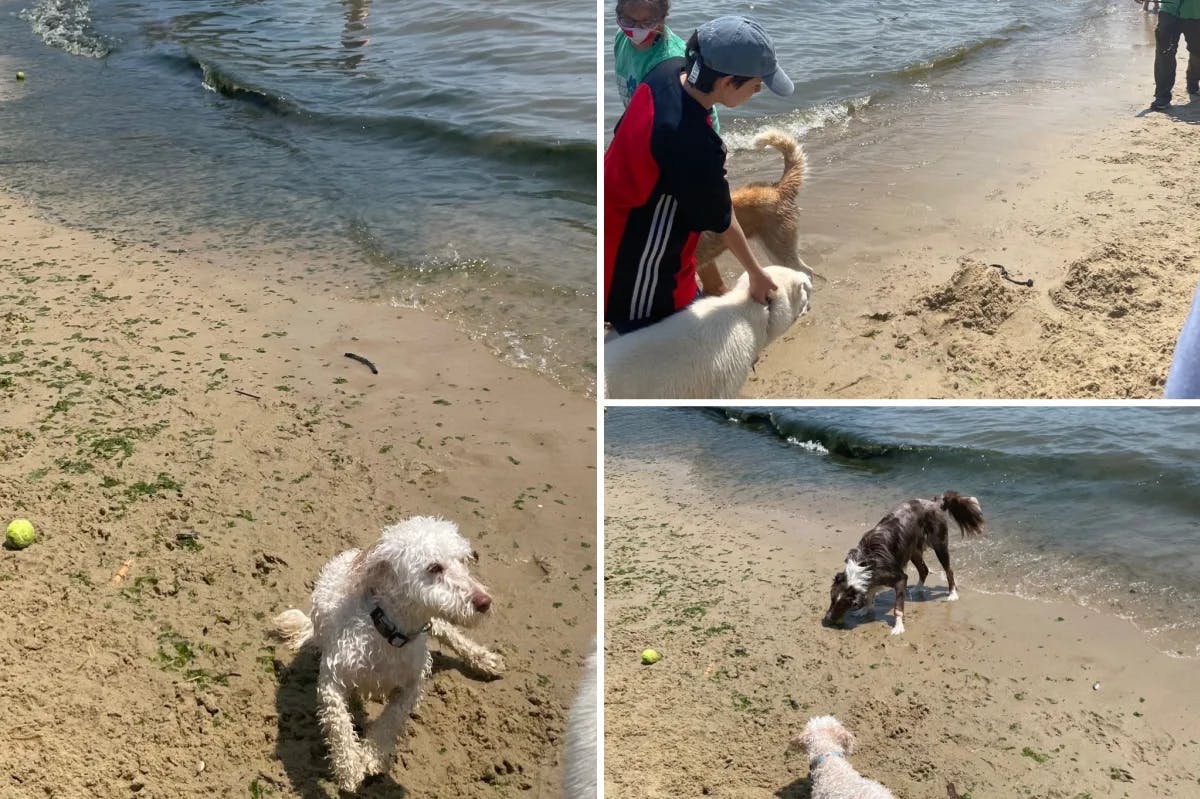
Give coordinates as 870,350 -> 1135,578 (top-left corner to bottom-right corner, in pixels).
700,74 -> 1200,398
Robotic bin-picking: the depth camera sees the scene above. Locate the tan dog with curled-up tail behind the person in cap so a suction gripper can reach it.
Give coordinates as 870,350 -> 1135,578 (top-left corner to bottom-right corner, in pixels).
696,128 -> 812,296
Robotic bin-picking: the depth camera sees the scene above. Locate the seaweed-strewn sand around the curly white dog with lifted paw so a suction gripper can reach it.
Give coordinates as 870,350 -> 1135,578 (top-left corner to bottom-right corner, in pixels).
0,194 -> 595,799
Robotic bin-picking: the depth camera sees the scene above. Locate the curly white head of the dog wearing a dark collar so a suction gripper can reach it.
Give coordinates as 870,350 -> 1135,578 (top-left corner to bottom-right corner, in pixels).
359,516 -> 492,626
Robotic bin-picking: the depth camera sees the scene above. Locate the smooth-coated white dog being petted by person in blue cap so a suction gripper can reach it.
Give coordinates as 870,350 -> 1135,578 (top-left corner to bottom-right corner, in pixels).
604,266 -> 812,400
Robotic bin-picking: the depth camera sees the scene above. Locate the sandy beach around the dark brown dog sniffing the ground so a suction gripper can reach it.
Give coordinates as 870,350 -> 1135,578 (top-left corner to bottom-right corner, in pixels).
605,458 -> 1200,799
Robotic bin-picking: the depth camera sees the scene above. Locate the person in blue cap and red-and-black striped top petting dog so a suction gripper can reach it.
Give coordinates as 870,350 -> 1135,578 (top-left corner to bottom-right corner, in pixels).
604,17 -> 793,335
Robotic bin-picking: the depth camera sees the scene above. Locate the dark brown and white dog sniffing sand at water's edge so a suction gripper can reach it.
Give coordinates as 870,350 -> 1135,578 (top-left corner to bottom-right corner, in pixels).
824,491 -> 984,636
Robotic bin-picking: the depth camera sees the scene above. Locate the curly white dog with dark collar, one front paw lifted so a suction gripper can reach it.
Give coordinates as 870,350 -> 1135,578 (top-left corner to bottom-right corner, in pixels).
275,516 -> 504,791
